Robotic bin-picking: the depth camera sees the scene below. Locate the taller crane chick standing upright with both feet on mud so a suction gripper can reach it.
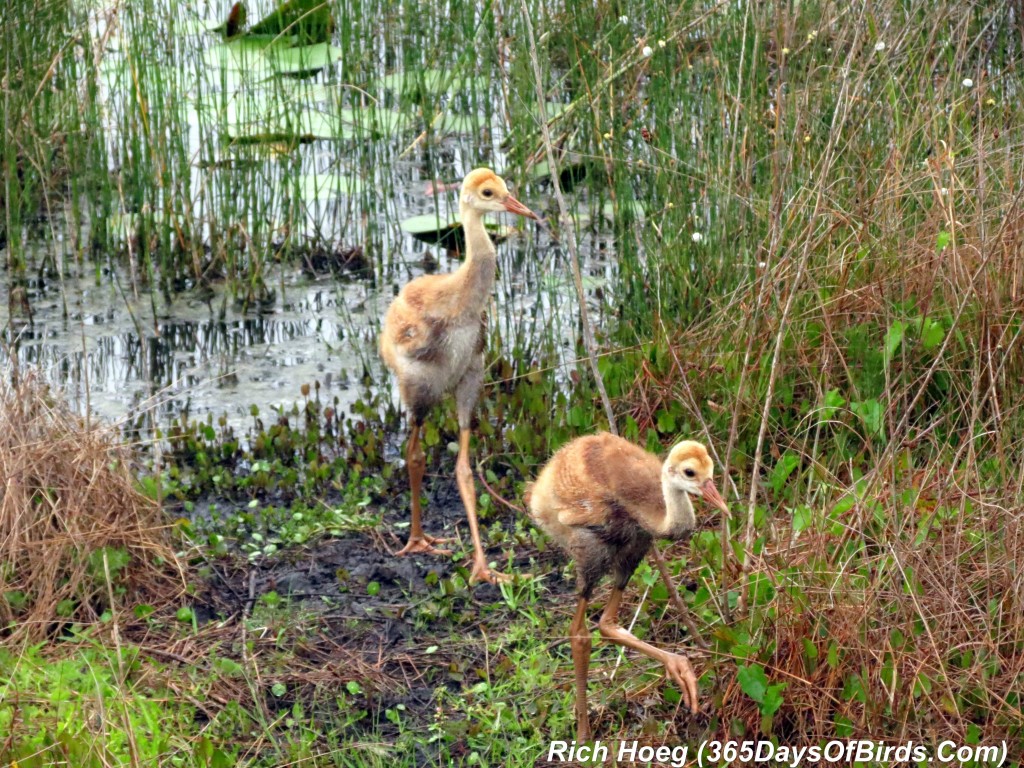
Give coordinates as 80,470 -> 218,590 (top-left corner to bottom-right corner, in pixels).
380,168 -> 537,582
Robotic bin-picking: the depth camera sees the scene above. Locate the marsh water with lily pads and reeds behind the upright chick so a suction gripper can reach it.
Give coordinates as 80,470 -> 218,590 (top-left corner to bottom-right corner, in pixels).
0,2 -> 630,424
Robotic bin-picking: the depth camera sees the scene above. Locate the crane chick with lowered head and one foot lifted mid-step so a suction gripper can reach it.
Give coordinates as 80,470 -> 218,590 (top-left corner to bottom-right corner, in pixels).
527,434 -> 728,741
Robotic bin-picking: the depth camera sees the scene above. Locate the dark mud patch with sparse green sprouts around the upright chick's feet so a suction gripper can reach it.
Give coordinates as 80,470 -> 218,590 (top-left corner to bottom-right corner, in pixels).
187,477 -> 574,738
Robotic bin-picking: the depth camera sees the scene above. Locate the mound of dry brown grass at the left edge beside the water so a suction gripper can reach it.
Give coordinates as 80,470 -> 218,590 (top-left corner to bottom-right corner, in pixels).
0,373 -> 184,641
